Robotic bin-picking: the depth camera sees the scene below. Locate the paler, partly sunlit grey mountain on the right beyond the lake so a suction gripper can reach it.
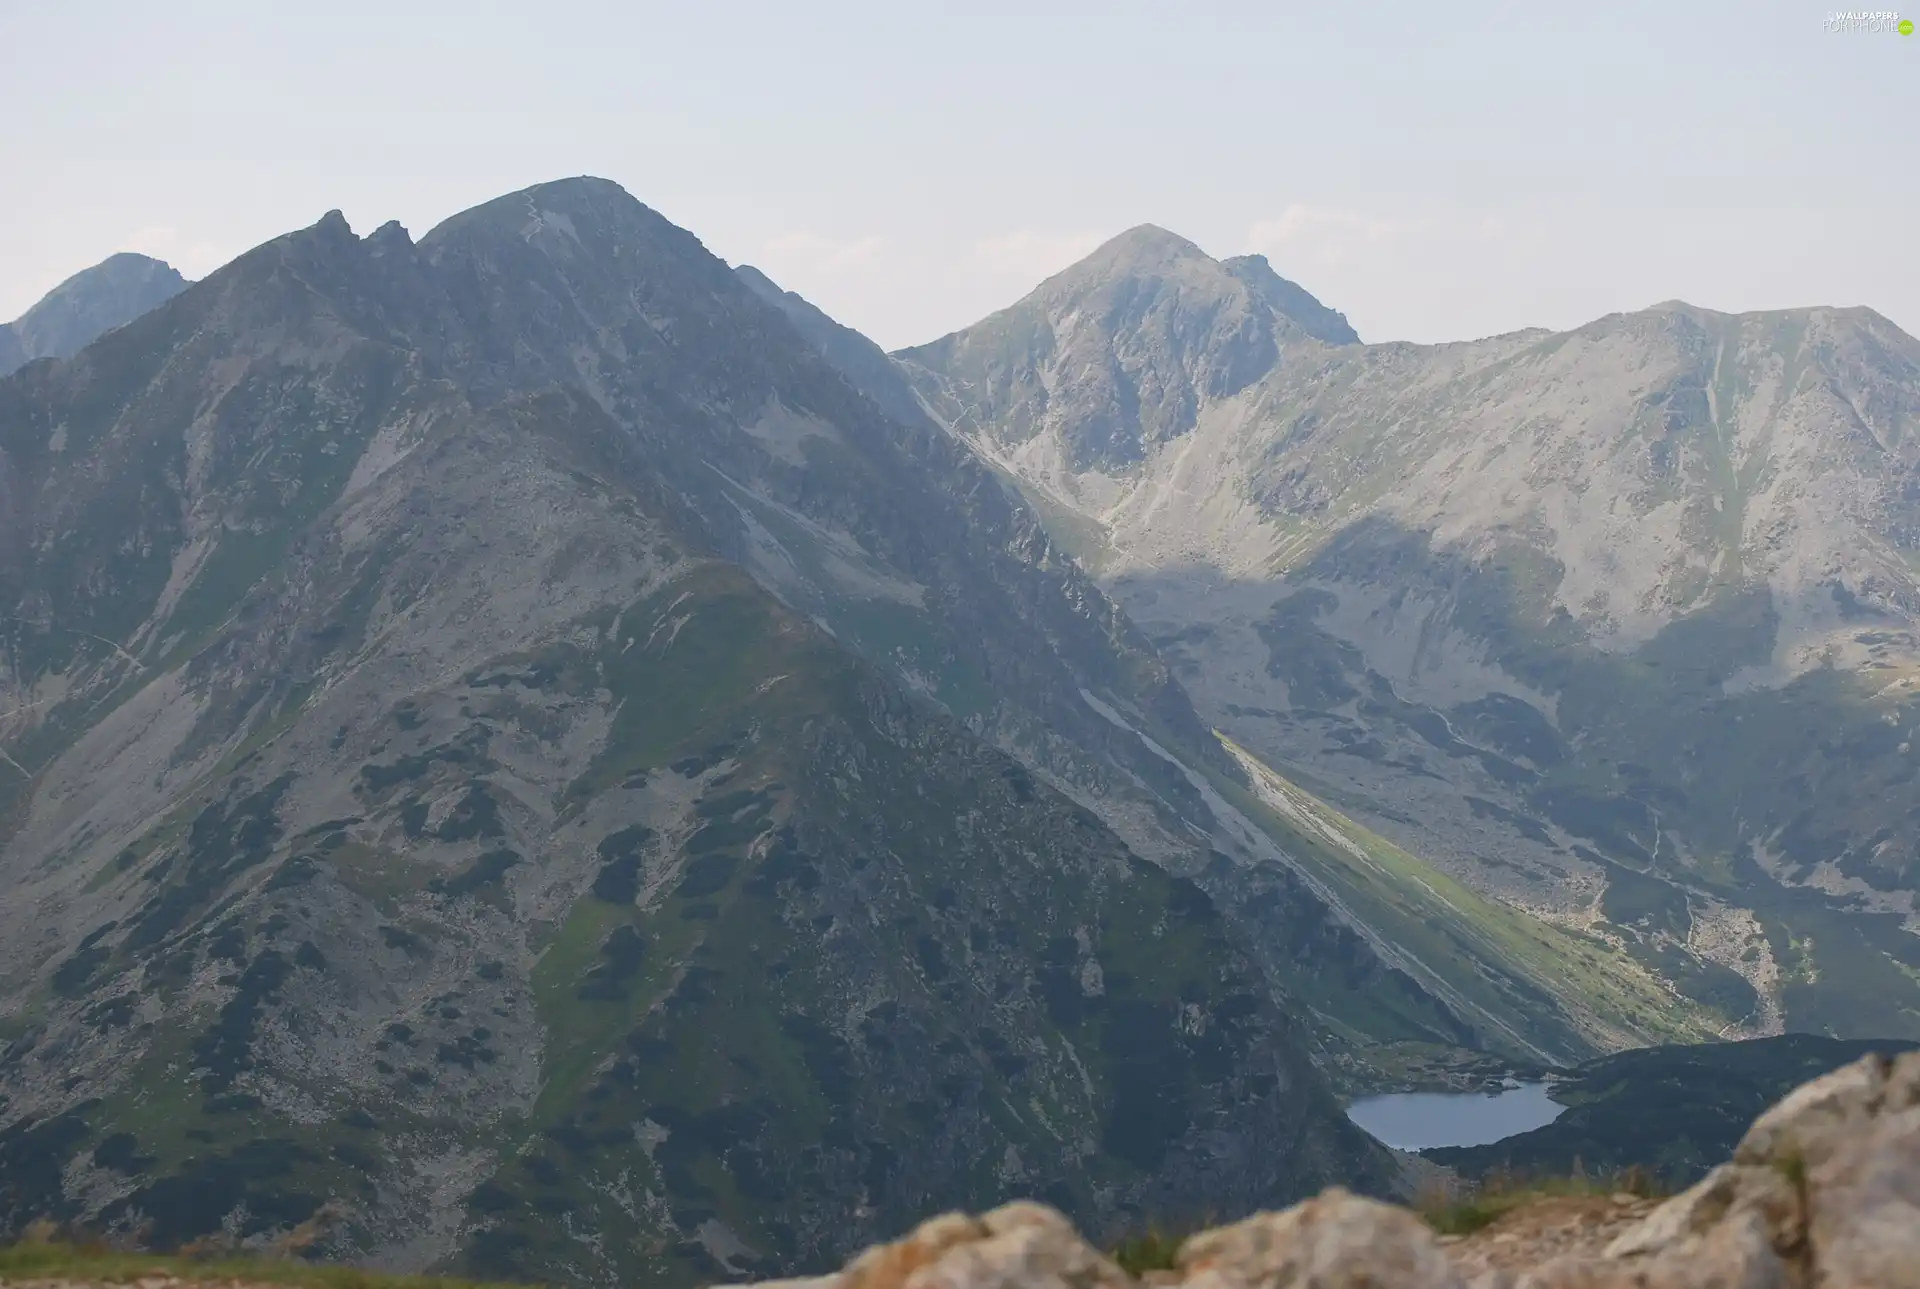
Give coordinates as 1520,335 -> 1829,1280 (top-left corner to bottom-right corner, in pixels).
893,227 -> 1920,1047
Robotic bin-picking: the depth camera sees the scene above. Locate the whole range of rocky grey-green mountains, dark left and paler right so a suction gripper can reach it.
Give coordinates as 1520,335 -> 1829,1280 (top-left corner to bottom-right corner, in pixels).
0,179 -> 1920,1283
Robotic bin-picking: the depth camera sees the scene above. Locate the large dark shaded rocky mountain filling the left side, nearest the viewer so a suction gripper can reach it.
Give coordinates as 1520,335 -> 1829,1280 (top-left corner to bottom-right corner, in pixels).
0,179 -> 1420,1283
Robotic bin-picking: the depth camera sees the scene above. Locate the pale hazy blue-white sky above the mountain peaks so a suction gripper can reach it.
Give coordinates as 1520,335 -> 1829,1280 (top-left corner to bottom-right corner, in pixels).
0,0 -> 1920,346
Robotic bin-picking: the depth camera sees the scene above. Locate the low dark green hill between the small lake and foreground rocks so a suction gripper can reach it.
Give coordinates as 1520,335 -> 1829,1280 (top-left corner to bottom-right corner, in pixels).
1421,1034 -> 1920,1189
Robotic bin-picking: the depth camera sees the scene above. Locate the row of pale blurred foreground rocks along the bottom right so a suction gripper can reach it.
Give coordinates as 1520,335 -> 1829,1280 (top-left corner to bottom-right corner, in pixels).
721,1053 -> 1920,1289
